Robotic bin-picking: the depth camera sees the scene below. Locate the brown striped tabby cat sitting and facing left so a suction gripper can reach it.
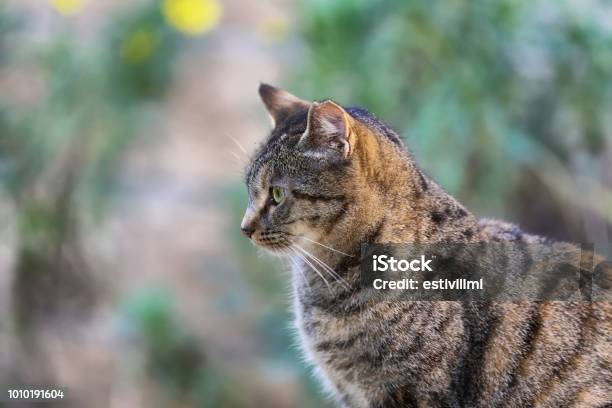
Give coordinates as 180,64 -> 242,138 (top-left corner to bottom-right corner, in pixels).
241,84 -> 612,407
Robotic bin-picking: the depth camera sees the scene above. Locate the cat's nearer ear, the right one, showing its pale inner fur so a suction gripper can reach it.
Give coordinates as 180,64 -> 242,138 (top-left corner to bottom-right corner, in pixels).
298,100 -> 351,158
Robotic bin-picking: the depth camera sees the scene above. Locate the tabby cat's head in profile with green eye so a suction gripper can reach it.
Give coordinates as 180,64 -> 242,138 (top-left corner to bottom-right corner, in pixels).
241,84 -> 400,253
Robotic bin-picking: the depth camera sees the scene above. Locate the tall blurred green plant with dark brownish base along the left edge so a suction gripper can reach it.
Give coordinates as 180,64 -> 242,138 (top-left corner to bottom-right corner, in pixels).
0,0 -> 213,334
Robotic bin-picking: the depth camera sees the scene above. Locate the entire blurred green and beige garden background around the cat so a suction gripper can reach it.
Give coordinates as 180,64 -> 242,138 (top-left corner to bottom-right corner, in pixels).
0,0 -> 612,407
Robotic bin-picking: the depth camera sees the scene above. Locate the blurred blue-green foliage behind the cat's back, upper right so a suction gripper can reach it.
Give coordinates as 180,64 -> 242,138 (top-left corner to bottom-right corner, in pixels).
296,0 -> 612,239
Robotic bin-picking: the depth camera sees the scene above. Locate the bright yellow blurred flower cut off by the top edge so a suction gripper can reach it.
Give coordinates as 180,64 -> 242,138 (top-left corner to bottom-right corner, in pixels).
162,0 -> 221,35
